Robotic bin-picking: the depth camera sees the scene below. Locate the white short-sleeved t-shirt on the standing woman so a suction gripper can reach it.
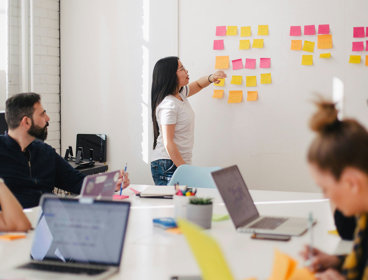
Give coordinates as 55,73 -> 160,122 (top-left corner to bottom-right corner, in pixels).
151,86 -> 194,164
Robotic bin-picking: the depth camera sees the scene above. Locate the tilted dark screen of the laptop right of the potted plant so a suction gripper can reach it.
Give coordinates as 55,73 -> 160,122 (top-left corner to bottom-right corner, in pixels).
211,165 -> 259,228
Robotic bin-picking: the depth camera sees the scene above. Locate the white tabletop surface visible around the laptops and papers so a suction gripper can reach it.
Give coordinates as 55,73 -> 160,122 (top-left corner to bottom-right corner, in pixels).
0,186 -> 351,280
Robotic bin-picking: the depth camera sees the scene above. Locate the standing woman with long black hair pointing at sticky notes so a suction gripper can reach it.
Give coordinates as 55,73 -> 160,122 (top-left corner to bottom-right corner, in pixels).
151,56 -> 226,185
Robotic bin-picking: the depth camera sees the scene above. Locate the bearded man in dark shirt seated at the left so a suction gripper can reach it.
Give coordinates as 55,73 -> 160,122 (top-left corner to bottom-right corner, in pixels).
0,93 -> 129,208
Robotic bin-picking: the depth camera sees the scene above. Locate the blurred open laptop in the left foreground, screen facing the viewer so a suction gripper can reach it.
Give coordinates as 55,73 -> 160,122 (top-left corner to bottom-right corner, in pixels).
4,195 -> 130,279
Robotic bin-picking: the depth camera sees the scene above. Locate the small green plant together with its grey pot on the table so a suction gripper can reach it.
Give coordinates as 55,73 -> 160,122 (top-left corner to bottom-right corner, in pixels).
187,197 -> 213,229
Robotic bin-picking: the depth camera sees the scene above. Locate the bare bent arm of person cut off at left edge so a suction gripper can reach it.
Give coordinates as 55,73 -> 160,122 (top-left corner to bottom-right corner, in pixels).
0,178 -> 31,231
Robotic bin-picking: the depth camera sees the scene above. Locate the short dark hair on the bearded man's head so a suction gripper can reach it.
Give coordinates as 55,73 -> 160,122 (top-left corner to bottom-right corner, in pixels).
5,92 -> 41,129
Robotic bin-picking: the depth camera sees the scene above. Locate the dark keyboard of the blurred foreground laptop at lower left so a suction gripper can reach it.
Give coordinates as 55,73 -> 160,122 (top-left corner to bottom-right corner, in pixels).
19,263 -> 106,275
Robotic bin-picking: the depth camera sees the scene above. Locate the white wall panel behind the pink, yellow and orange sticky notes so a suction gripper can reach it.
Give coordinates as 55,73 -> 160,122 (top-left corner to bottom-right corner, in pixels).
179,0 -> 368,191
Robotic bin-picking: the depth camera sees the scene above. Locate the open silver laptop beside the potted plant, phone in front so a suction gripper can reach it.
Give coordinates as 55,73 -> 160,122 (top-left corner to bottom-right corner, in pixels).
211,165 -> 309,235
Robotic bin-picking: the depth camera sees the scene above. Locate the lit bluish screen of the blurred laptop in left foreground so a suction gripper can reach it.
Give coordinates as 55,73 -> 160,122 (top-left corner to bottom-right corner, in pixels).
31,196 -> 130,266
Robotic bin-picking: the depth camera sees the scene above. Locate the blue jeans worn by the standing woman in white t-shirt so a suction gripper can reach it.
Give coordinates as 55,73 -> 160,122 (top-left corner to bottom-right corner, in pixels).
151,159 -> 176,186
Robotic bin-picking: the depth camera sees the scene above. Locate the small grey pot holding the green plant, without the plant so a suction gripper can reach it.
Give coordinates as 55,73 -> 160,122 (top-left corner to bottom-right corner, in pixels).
187,203 -> 213,229
